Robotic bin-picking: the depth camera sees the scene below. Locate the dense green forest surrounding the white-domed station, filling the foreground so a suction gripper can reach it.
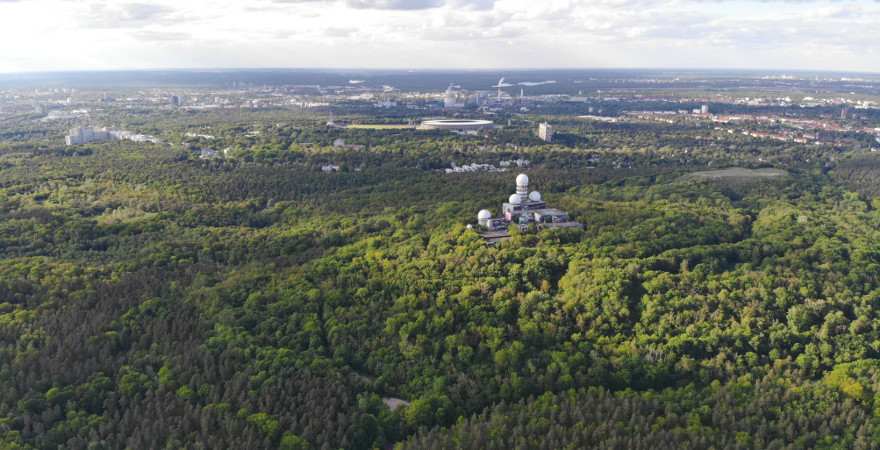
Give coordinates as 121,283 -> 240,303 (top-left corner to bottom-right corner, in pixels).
0,135 -> 880,449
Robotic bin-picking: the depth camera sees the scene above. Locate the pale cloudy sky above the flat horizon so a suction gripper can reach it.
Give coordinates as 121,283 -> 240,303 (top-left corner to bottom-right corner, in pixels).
0,0 -> 880,72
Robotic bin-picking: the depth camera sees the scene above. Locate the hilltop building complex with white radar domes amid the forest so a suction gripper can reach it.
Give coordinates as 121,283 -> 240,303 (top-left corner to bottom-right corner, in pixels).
477,173 -> 583,245
